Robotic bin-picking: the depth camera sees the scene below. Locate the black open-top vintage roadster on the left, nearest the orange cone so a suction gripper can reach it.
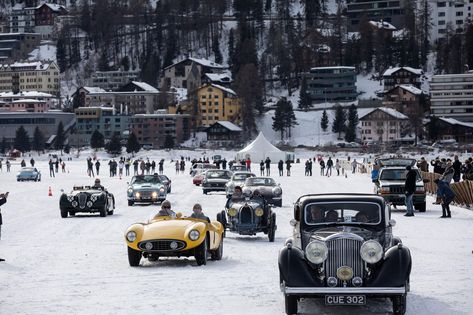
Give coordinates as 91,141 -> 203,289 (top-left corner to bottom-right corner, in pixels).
59,186 -> 115,218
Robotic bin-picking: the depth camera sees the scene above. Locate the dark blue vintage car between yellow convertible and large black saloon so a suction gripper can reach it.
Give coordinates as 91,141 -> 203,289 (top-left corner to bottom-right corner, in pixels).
217,196 -> 277,242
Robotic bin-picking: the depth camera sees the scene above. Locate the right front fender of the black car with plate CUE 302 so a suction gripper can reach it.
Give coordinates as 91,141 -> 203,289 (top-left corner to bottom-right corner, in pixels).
367,243 -> 412,287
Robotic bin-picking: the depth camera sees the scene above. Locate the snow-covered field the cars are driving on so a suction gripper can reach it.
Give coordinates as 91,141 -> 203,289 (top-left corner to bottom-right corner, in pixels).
0,151 -> 473,315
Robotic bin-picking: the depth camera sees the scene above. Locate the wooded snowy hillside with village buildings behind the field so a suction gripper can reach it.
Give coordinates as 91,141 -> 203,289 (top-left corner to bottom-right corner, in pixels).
0,0 -> 473,152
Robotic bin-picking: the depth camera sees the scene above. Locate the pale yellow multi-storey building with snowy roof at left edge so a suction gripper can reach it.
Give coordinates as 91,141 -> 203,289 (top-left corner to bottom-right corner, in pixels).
0,61 -> 60,95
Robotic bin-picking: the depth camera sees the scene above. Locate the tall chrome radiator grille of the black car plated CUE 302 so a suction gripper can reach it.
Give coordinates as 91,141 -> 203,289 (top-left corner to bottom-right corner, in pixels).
325,238 -> 364,286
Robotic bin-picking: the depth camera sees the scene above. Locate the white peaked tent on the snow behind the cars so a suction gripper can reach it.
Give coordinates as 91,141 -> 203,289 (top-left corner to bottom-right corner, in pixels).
235,132 -> 294,163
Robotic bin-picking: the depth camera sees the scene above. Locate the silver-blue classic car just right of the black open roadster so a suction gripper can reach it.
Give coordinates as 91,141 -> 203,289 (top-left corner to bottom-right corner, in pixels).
127,174 -> 168,206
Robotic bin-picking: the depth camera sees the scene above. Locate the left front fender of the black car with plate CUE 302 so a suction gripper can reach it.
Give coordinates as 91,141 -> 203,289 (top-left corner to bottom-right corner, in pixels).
278,245 -> 323,287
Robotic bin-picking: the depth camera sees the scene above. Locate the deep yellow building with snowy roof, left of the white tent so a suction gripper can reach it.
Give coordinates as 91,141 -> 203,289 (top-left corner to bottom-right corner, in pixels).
197,84 -> 241,126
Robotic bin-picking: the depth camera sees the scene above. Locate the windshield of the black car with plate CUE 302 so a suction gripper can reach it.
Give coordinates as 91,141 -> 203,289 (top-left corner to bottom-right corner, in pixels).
304,201 -> 381,225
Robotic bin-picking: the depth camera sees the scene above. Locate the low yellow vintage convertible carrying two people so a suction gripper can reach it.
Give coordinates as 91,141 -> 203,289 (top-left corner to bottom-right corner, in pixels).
125,213 -> 224,267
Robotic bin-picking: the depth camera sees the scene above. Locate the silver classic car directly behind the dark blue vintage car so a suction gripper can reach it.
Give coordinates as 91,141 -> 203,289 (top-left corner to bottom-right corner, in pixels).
243,177 -> 282,207
